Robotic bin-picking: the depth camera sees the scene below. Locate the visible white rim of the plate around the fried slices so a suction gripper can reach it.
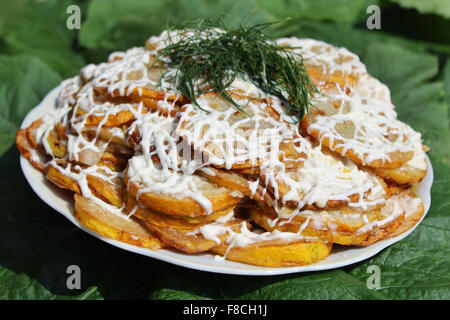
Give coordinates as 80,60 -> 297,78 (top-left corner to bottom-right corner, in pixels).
20,85 -> 434,276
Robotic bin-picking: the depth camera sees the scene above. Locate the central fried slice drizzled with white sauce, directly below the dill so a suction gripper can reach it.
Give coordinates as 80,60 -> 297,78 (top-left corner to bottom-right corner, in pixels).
176,92 -> 305,169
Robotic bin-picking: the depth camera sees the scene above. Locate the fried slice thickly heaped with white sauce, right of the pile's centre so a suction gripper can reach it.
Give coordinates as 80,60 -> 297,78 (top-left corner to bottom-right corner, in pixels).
260,145 -> 387,209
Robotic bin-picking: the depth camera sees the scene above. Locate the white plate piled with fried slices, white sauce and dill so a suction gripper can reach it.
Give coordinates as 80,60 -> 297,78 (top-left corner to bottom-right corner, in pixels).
16,23 -> 433,275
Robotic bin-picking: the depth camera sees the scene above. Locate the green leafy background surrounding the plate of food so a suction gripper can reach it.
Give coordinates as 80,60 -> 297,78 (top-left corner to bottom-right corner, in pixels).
0,0 -> 450,299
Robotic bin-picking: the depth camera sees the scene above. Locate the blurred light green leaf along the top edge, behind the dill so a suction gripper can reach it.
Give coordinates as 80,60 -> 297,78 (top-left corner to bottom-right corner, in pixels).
80,0 -> 367,50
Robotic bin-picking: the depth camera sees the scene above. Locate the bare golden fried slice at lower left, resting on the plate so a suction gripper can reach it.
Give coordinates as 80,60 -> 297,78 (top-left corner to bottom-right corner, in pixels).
75,194 -> 164,250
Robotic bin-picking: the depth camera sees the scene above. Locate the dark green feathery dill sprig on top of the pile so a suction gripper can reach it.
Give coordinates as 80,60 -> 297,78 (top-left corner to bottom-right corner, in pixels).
157,20 -> 317,119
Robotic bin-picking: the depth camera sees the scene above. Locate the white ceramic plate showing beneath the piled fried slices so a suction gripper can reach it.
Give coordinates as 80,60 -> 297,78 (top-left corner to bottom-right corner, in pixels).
20,87 -> 433,275
